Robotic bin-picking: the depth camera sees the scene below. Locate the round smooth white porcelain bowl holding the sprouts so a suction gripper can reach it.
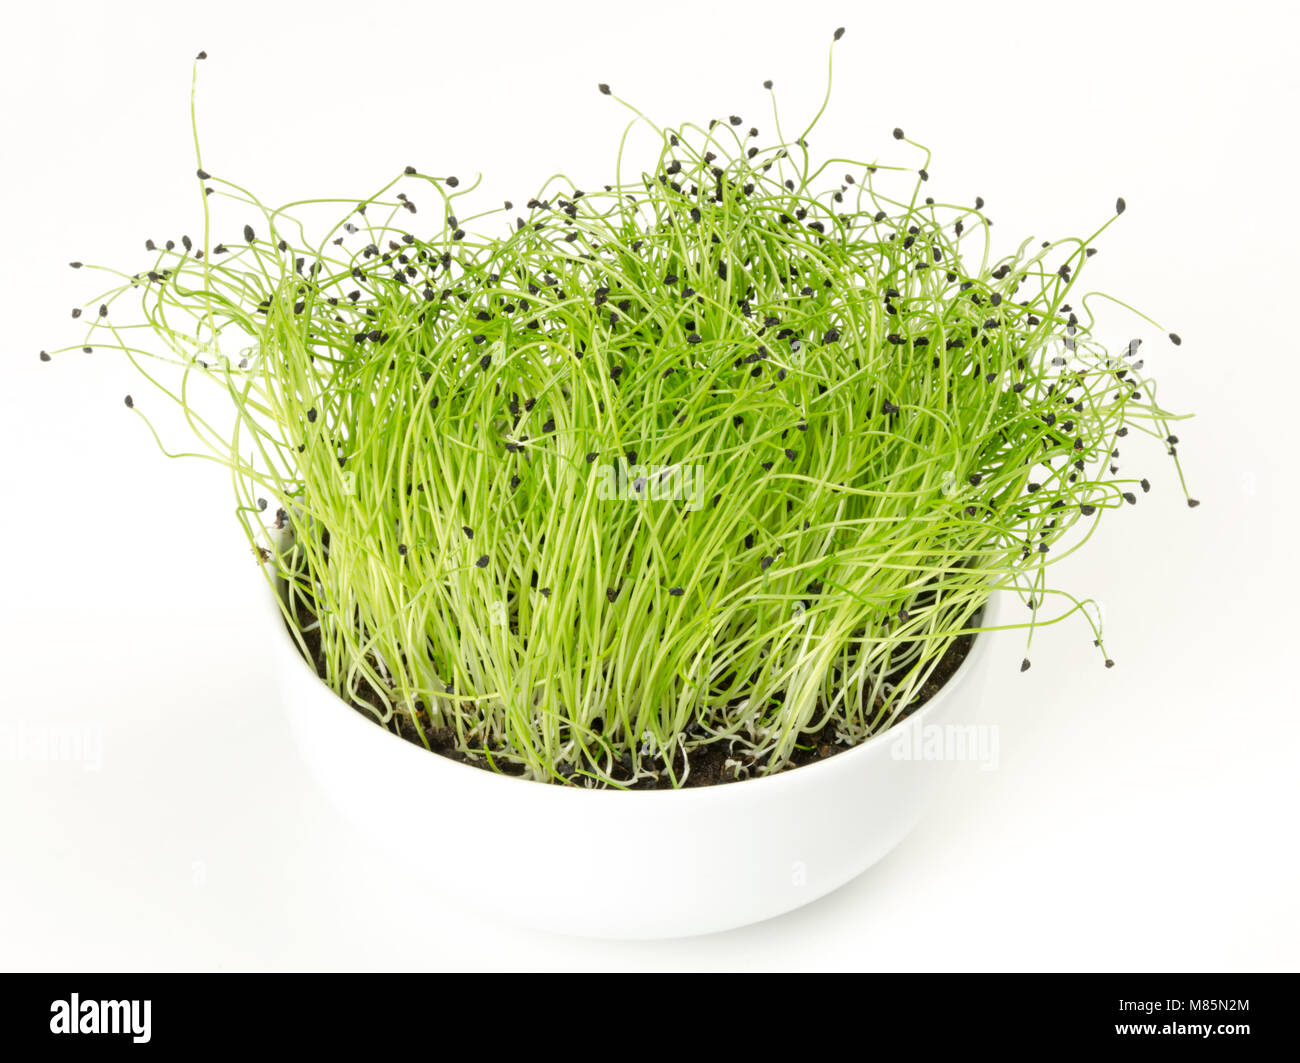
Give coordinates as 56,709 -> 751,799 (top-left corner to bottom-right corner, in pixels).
272,595 -> 998,938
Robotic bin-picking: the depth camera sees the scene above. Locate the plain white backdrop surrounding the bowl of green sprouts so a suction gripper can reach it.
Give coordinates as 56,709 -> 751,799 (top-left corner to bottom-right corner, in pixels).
0,0 -> 1300,969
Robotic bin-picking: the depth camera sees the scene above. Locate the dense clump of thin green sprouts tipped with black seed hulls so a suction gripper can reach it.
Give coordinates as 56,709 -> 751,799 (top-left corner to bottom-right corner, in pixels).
50,35 -> 1195,785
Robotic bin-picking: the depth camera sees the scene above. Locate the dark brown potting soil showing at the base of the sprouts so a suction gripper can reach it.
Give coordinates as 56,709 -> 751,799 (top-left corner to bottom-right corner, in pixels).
287,605 -> 975,790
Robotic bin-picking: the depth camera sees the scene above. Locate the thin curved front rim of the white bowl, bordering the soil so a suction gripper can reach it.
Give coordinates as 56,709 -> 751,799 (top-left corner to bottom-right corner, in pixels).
267,579 -> 1005,803
